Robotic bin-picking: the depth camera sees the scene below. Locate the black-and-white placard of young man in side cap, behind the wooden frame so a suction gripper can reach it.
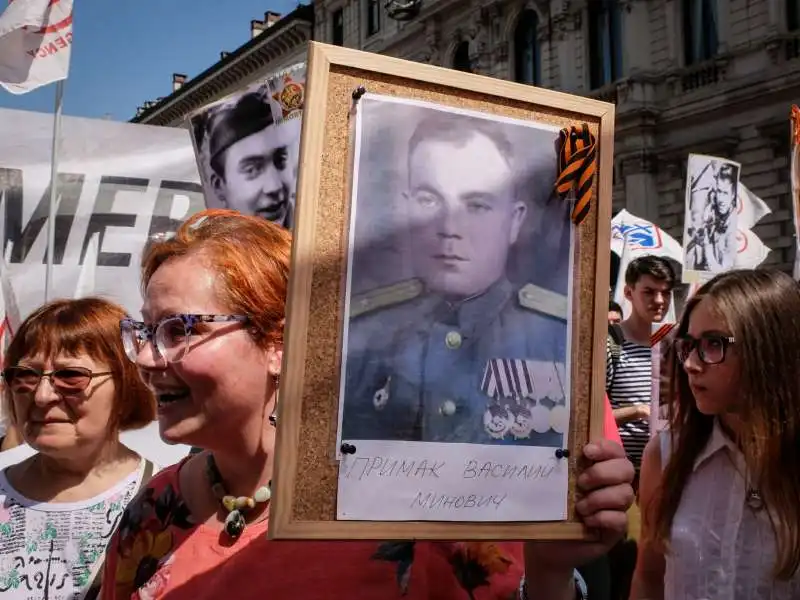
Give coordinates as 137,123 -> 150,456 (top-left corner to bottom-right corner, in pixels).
189,65 -> 305,229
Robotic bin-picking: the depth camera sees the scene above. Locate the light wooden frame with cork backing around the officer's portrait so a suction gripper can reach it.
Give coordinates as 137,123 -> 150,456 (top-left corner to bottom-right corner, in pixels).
268,42 -> 614,540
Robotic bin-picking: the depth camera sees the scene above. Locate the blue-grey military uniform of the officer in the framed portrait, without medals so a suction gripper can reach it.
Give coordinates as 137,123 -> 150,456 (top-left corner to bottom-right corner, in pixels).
342,278 -> 568,447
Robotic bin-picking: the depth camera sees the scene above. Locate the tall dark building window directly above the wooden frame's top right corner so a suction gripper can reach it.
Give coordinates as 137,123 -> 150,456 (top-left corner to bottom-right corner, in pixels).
589,0 -> 622,90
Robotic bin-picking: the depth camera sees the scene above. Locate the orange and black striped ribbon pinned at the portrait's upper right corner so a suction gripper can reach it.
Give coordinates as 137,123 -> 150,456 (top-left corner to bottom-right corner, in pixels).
555,123 -> 597,225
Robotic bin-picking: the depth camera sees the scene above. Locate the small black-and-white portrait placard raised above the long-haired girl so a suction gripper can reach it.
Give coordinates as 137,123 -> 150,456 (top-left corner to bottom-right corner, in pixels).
683,154 -> 741,275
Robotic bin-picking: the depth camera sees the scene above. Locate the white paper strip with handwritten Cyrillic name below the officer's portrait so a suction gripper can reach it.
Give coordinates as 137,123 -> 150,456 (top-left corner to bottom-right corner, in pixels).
337,440 -> 569,522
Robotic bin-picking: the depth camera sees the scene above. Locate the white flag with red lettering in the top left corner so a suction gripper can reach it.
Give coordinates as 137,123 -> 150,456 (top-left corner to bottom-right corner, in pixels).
0,0 -> 73,94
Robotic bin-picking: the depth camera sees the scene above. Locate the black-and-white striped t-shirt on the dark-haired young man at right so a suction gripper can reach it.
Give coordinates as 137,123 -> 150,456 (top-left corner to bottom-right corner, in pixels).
606,340 -> 653,471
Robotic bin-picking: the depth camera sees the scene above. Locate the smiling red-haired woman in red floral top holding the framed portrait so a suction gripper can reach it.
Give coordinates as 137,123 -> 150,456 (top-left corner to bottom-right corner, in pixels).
102,211 -> 633,600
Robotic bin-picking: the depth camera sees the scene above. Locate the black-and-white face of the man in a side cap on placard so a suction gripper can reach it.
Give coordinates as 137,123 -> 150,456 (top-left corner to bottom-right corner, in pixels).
219,125 -> 294,224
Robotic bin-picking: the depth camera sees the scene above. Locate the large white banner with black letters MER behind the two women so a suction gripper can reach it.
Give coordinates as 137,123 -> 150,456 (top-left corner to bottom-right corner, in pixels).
0,109 -> 204,318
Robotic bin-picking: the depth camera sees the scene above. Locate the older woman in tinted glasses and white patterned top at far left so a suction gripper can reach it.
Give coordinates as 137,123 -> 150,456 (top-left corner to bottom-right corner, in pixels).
0,298 -> 155,600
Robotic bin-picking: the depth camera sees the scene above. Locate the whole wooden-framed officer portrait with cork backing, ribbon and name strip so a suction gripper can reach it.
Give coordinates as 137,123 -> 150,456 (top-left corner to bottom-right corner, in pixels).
269,43 -> 614,539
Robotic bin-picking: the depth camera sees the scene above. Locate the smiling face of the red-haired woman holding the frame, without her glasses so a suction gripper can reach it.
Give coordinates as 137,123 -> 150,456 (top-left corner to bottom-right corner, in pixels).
137,255 -> 280,448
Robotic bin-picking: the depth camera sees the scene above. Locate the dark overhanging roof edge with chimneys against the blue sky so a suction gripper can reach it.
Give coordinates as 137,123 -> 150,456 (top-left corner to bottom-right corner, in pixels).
131,5 -> 314,127
